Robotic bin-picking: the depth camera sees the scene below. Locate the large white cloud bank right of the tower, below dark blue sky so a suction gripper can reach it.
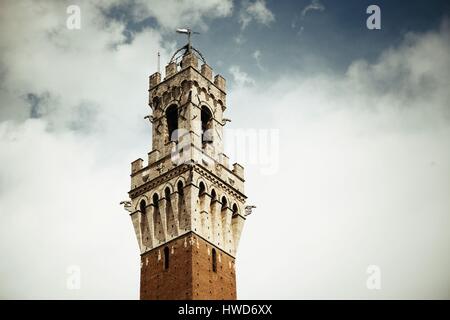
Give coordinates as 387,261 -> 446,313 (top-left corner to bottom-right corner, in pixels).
226,24 -> 450,299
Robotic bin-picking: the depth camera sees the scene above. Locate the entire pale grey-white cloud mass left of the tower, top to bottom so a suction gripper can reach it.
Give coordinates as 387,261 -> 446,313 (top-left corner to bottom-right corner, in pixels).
0,1 -> 168,299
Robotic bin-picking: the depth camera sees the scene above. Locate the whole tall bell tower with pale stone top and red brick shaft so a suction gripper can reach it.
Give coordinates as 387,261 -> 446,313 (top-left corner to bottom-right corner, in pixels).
127,35 -> 246,300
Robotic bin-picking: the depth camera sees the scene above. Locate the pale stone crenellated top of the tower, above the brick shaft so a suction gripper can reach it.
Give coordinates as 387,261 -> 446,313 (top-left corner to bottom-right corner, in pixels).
129,37 -> 246,257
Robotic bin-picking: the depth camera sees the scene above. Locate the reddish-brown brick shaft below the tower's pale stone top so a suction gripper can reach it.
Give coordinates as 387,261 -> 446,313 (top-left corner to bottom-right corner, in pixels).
140,233 -> 236,300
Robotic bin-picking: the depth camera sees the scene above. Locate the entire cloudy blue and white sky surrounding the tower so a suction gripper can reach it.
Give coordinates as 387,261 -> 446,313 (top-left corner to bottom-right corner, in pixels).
0,0 -> 450,299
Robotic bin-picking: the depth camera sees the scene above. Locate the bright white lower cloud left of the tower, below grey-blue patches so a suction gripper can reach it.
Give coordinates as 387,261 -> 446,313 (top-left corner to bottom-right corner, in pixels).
0,119 -> 139,299
